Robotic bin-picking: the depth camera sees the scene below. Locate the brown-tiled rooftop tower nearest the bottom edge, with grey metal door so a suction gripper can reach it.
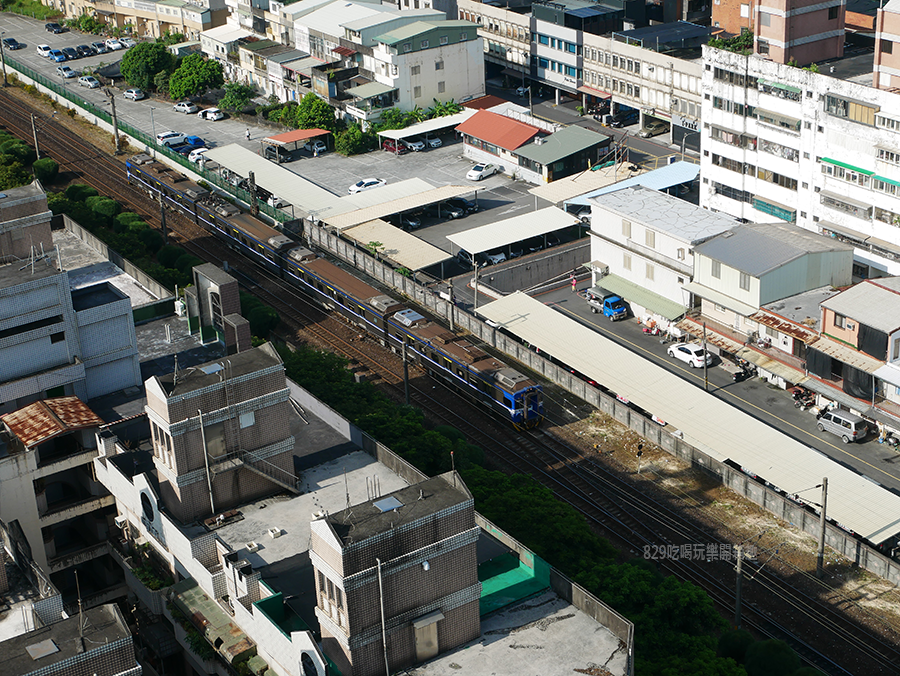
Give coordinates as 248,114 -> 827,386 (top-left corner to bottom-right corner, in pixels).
310,472 -> 481,676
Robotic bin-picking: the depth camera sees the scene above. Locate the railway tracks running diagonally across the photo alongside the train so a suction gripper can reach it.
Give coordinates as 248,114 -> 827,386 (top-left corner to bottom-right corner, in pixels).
0,92 -> 900,674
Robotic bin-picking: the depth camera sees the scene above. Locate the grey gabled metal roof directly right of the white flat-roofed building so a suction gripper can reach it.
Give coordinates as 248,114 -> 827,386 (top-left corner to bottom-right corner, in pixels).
694,223 -> 853,277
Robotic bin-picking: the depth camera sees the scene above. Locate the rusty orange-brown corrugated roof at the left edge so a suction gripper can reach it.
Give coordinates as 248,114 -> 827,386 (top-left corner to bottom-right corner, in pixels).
0,397 -> 104,448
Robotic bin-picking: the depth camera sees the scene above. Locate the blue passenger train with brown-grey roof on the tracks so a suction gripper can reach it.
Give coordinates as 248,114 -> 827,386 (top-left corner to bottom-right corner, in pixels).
125,154 -> 544,429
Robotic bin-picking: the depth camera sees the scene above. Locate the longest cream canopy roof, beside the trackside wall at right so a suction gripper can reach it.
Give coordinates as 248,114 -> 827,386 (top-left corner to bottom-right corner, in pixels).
478,292 -> 900,543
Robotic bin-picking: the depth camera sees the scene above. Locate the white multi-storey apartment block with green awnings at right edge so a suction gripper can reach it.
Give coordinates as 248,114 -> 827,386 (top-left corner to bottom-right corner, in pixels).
700,47 -> 900,278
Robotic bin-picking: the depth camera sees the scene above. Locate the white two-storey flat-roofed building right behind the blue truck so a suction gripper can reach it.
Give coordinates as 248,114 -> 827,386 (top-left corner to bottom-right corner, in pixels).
589,185 -> 738,328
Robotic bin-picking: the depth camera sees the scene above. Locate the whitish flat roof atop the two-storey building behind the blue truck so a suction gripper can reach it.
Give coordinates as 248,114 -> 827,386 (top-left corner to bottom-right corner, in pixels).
590,185 -> 738,245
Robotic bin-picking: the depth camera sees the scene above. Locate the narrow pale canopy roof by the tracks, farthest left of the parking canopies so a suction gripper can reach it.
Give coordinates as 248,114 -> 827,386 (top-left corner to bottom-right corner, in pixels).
204,143 -> 340,216
